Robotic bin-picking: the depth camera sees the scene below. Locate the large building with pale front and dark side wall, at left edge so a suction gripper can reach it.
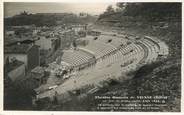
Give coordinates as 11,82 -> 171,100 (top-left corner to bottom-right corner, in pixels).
4,43 -> 40,71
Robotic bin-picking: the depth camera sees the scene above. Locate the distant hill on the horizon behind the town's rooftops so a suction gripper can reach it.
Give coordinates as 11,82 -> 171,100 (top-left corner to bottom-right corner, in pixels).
4,12 -> 96,26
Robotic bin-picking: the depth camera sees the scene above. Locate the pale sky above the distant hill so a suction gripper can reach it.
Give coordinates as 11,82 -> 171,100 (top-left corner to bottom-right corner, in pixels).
4,2 -> 115,17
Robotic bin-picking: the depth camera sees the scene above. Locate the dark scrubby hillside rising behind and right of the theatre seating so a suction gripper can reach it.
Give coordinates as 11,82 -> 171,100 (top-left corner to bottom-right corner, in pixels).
93,3 -> 181,111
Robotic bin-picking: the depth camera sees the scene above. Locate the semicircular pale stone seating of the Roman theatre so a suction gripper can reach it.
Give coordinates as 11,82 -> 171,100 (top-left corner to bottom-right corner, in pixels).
35,32 -> 168,98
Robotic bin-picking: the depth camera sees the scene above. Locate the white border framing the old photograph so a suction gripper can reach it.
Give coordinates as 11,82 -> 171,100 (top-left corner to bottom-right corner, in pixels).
0,0 -> 184,115
